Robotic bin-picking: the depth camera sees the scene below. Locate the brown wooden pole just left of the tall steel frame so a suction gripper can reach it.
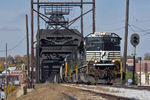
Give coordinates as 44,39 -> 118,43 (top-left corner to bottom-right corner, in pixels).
26,14 -> 30,77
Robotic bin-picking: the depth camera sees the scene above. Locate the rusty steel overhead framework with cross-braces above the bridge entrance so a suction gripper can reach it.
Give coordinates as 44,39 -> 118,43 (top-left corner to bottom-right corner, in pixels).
31,0 -> 95,83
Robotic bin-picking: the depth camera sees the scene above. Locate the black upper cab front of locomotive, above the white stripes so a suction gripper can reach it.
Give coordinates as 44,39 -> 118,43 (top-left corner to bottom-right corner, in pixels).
86,36 -> 121,51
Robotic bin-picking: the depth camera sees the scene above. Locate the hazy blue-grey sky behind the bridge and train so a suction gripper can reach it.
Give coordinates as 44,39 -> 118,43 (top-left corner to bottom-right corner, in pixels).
0,0 -> 150,57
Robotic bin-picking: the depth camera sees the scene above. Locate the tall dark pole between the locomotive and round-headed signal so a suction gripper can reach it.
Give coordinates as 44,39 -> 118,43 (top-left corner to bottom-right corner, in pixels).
123,0 -> 129,83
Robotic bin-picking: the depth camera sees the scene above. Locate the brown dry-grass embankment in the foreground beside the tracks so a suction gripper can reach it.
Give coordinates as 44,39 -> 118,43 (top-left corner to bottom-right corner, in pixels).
8,83 -> 106,100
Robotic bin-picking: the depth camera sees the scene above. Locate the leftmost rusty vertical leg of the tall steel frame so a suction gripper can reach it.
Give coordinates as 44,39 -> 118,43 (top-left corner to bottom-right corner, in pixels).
31,0 -> 34,85
